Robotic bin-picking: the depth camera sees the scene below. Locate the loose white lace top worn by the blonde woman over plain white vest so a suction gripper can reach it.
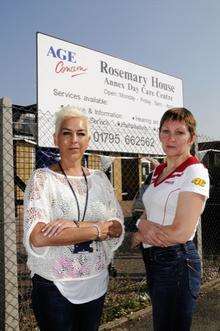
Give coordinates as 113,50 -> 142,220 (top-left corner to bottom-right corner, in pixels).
24,168 -> 124,281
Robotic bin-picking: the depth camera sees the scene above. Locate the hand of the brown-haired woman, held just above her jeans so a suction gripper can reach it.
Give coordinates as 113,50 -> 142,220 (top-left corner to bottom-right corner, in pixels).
138,219 -> 170,247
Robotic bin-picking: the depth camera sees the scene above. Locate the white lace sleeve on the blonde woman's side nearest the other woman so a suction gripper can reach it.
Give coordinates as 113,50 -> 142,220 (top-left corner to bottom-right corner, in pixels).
97,172 -> 124,261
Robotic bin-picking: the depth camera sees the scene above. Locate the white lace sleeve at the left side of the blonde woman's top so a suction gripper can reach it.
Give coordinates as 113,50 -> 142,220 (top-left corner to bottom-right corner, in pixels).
23,169 -> 50,256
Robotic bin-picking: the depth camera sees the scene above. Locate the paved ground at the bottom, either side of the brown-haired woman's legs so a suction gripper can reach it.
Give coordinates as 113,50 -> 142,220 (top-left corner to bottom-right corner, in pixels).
101,279 -> 220,331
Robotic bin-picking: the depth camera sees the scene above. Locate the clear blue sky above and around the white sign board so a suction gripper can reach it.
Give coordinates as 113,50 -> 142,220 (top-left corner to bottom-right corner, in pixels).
0,0 -> 220,140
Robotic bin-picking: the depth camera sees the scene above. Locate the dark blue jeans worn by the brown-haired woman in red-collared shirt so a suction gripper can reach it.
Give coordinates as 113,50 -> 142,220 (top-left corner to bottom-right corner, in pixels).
142,241 -> 201,331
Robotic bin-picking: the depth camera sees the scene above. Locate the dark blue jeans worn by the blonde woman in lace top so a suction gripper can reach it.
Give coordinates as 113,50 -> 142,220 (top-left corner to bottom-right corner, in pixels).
32,274 -> 105,331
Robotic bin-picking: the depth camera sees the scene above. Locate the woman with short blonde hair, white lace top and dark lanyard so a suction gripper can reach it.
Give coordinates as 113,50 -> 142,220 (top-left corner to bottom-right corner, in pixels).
24,106 -> 123,331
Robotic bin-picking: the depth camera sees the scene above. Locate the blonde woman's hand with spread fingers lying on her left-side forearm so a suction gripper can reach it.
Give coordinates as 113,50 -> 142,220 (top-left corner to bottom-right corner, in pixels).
41,219 -> 77,238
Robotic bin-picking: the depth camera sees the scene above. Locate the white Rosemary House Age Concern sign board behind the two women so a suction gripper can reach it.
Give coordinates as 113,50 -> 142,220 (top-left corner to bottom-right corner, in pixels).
37,33 -> 183,154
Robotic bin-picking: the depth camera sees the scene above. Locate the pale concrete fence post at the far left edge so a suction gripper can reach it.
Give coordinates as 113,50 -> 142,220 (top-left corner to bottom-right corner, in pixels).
0,97 -> 19,331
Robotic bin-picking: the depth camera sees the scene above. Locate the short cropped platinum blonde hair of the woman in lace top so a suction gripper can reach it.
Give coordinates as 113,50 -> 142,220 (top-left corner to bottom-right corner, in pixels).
55,105 -> 91,136
